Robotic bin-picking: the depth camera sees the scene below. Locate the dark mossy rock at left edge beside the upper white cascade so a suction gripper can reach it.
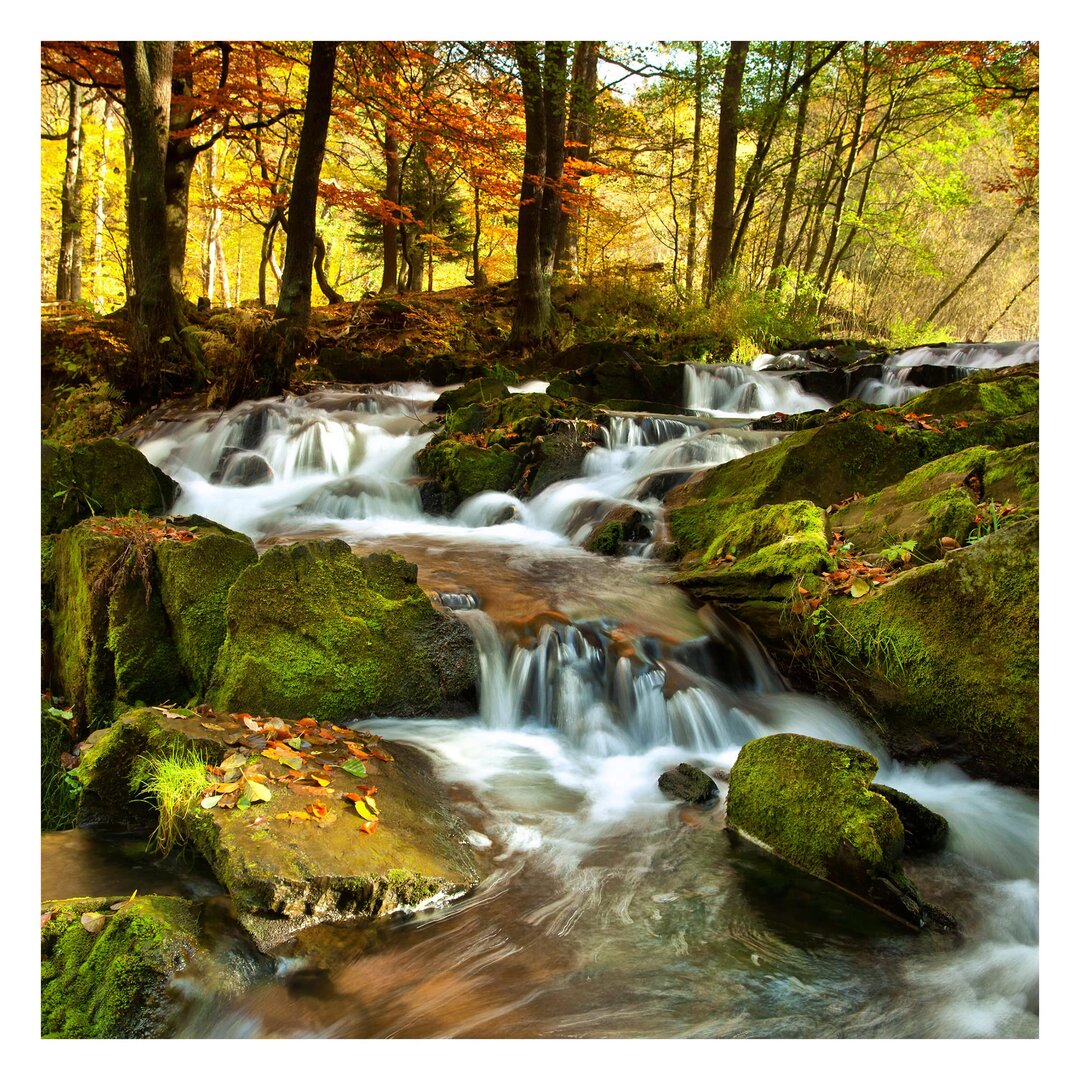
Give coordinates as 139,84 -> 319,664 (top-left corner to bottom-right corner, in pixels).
41,438 -> 180,534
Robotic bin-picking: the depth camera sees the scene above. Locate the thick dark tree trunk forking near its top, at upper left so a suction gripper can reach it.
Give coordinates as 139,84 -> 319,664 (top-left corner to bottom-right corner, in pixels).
120,41 -> 190,396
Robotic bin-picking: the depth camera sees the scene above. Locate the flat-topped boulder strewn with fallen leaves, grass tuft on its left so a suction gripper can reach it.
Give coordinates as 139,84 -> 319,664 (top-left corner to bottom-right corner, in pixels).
78,708 -> 480,946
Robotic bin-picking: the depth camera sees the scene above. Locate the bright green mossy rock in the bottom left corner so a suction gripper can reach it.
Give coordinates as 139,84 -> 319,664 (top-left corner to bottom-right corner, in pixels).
41,896 -> 199,1039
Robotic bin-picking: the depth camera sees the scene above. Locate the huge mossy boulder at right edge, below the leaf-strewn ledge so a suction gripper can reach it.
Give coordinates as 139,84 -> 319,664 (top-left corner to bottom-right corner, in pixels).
800,516 -> 1039,787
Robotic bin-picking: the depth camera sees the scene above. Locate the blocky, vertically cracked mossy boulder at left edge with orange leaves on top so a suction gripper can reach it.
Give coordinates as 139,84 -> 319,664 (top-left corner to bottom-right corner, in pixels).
48,515 -> 257,732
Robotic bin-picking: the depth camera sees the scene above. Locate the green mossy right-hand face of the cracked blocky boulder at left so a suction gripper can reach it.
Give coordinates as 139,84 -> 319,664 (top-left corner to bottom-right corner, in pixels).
154,518 -> 258,696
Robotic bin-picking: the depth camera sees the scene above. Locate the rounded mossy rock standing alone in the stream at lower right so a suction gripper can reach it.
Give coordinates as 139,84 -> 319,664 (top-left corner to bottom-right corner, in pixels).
727,734 -> 946,928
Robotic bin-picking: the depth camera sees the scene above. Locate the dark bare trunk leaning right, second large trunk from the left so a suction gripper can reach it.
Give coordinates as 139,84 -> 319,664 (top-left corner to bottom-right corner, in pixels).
275,41 -> 337,330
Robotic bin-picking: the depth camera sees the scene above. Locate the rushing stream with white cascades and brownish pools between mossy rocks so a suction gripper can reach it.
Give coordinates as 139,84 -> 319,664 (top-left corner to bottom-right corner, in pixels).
43,354 -> 1039,1038
